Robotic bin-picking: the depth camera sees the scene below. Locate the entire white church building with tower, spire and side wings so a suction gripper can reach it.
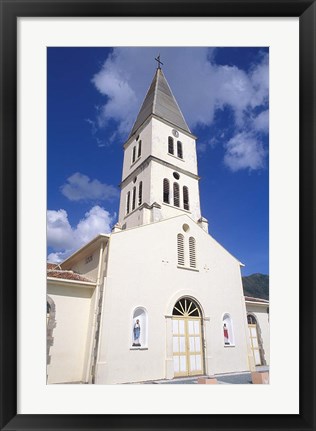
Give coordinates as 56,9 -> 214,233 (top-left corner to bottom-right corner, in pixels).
47,66 -> 269,384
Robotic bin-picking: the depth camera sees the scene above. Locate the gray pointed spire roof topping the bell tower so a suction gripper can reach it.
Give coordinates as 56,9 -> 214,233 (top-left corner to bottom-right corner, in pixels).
129,67 -> 191,137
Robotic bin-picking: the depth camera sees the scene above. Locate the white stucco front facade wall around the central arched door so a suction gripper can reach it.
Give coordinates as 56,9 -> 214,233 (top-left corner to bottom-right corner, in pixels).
96,216 -> 249,384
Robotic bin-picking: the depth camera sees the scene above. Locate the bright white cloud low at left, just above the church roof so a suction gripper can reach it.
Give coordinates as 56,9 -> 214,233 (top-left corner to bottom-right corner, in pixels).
47,205 -> 116,262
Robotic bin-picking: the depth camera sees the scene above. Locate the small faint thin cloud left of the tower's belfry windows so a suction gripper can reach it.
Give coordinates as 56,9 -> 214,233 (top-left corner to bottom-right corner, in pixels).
60,172 -> 119,201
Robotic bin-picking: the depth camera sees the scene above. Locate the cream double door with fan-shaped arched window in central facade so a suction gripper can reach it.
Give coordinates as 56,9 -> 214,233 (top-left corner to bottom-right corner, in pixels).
172,298 -> 204,377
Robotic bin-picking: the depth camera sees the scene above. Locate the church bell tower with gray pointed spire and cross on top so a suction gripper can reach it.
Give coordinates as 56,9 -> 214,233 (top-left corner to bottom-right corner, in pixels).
119,57 -> 207,235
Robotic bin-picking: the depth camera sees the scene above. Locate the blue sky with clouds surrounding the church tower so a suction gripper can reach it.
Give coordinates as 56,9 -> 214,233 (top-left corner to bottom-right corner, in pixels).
47,47 -> 269,275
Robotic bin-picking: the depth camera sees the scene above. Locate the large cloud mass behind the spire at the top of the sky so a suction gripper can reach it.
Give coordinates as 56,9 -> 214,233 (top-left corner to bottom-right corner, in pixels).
92,48 -> 269,133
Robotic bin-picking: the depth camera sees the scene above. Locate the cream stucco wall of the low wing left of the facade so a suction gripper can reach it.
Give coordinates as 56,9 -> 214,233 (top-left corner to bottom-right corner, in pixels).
47,282 -> 94,383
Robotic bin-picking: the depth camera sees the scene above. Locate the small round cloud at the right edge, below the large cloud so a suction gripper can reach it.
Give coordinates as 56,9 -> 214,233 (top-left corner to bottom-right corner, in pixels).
224,133 -> 266,172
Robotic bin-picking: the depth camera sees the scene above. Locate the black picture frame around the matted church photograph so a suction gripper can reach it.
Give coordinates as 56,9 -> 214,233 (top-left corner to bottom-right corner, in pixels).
0,0 -> 316,431
